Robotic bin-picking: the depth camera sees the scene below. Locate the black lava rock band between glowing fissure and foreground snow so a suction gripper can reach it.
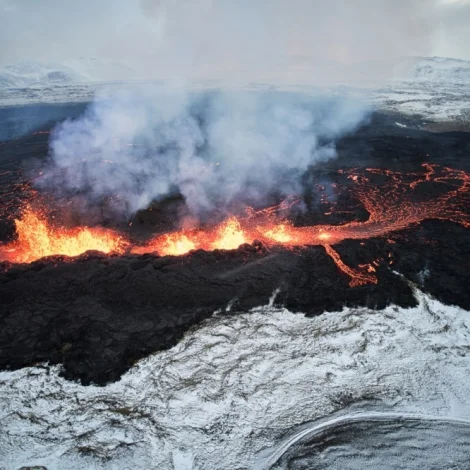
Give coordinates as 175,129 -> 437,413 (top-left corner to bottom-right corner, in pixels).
0,217 -> 470,385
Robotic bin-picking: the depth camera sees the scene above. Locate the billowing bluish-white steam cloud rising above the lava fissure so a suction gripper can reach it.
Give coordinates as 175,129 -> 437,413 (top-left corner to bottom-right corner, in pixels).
41,88 -> 367,218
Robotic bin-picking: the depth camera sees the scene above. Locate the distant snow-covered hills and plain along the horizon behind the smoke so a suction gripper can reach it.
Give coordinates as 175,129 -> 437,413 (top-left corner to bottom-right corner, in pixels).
0,57 -> 470,122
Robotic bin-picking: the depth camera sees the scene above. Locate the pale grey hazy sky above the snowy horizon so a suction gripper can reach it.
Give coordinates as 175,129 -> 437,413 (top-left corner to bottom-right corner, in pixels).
0,0 -> 470,73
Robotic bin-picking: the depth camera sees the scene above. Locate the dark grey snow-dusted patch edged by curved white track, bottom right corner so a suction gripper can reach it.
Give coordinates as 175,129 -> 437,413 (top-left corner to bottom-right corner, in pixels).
265,415 -> 470,470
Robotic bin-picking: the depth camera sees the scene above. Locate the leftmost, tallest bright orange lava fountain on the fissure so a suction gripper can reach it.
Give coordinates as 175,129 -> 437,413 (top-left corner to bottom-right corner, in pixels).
0,206 -> 126,263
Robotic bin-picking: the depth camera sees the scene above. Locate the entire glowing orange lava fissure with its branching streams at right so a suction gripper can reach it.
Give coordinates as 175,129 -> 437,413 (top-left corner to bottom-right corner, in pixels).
0,164 -> 470,287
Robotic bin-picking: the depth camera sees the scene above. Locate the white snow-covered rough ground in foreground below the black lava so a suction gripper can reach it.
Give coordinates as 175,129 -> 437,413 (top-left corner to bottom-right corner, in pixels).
0,292 -> 470,470
